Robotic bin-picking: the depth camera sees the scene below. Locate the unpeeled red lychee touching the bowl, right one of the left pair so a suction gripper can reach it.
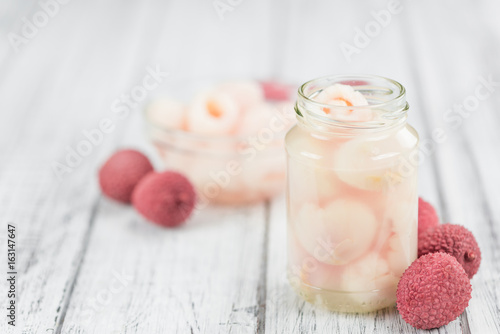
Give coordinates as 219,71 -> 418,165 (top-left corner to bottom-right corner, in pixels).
132,171 -> 196,227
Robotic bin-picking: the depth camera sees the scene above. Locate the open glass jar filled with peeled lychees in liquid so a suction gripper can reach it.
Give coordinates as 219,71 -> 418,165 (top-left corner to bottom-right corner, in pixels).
285,75 -> 418,312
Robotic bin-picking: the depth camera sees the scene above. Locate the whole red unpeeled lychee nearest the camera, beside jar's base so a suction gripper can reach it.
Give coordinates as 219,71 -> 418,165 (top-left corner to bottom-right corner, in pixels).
396,253 -> 472,329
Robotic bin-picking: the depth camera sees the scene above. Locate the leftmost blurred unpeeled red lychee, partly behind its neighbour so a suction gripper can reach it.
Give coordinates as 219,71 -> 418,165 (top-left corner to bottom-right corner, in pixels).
99,150 -> 153,203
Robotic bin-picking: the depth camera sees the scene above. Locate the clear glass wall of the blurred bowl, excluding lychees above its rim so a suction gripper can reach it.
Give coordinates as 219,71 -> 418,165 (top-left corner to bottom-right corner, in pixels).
144,80 -> 295,205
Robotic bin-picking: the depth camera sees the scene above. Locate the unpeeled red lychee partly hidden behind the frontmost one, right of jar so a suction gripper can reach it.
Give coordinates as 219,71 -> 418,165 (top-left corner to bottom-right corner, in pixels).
418,224 -> 481,278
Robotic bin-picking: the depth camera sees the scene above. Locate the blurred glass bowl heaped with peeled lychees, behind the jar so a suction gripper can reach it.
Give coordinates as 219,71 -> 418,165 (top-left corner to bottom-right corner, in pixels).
145,80 -> 295,205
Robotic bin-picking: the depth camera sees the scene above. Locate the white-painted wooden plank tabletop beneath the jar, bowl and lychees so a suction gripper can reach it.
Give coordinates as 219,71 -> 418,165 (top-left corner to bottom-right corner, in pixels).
0,0 -> 500,334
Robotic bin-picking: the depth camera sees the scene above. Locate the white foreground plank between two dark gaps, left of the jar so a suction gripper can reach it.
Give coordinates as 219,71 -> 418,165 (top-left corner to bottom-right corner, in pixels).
62,200 -> 265,333
